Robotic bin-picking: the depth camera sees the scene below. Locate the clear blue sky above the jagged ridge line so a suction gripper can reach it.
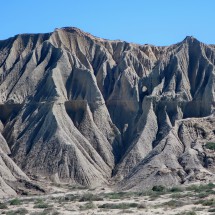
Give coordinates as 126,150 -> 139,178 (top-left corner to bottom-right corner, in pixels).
0,0 -> 215,45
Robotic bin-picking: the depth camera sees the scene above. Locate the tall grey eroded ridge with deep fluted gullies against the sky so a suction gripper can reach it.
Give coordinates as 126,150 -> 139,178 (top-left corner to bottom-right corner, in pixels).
0,28 -> 215,193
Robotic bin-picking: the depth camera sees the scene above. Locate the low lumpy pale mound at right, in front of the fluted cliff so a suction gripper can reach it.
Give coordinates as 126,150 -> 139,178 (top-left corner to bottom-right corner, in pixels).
120,116 -> 215,190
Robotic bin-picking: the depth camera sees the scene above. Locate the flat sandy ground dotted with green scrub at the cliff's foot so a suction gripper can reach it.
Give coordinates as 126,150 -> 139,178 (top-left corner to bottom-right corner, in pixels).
0,183 -> 215,215
